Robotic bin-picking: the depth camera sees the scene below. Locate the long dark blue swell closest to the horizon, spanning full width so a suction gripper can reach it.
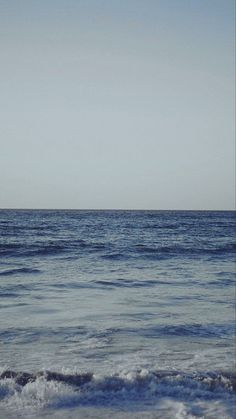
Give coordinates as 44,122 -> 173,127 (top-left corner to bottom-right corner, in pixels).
0,236 -> 236,261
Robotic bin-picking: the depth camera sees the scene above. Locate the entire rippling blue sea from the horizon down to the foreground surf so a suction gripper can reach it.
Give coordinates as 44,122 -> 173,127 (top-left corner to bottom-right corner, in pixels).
0,210 -> 236,419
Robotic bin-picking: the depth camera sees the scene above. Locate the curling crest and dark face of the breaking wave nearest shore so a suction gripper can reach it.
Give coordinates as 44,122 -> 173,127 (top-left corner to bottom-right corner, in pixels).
0,369 -> 236,401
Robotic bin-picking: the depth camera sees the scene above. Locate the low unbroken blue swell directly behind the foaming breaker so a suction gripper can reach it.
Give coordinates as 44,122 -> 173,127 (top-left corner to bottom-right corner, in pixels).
0,323 -> 232,345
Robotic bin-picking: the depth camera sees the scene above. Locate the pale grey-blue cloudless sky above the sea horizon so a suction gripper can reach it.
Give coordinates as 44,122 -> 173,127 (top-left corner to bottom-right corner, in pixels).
0,0 -> 235,210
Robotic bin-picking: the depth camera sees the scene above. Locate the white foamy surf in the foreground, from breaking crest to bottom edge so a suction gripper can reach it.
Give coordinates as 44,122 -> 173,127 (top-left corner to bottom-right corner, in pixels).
0,369 -> 234,419
